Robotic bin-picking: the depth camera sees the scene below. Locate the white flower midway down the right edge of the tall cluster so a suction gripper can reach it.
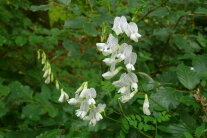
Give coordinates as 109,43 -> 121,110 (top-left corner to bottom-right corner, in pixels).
124,52 -> 137,71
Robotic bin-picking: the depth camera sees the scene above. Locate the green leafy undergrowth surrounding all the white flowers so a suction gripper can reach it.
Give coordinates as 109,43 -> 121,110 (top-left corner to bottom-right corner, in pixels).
0,0 -> 207,138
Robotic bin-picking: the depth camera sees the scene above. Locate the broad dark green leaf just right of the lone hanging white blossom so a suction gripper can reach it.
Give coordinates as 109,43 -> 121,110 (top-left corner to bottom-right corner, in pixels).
150,87 -> 182,110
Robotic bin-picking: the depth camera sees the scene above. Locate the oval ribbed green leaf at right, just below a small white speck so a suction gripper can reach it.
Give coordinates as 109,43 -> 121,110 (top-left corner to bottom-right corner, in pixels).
177,64 -> 200,90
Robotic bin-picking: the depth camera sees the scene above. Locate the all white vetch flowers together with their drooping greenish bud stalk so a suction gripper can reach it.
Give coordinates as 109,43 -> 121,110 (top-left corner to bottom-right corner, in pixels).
37,16 -> 151,125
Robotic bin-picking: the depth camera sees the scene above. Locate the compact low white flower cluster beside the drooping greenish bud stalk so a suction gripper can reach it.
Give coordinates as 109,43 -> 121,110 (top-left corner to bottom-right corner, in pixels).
68,82 -> 106,125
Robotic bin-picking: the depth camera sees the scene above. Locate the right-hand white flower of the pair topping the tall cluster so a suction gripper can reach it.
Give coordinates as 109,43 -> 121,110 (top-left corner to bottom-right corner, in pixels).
124,22 -> 141,42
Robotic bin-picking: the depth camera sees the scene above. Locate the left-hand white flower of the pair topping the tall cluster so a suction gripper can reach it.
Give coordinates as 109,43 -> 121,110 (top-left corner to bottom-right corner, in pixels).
112,16 -> 128,35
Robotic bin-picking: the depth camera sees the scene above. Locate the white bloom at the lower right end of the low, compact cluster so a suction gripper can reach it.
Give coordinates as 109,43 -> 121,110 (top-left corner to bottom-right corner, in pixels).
84,104 -> 106,126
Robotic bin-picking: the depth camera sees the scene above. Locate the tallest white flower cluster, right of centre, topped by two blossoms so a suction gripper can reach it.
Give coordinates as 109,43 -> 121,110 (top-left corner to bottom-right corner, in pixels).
96,16 -> 141,103
